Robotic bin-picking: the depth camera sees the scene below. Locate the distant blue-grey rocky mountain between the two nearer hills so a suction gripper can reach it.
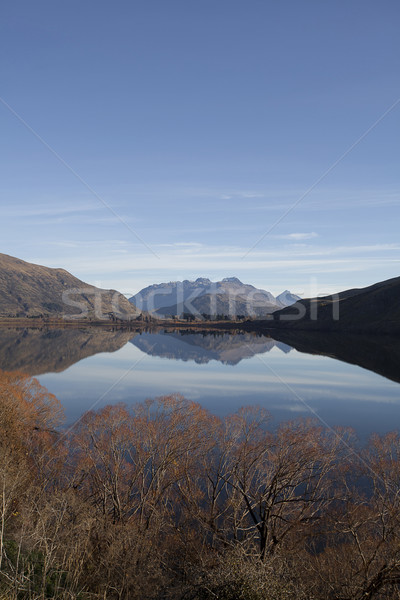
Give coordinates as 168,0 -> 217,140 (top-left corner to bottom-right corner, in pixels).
130,277 -> 299,317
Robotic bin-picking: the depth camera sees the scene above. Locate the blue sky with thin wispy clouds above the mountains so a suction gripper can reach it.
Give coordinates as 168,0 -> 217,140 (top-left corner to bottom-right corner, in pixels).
0,0 -> 400,295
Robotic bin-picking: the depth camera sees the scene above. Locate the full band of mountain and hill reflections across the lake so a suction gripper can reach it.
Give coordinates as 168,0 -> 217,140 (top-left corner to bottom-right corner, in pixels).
0,327 -> 400,382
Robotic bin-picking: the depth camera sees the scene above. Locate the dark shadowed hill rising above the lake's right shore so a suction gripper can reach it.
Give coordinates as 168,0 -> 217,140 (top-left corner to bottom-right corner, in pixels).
266,277 -> 400,334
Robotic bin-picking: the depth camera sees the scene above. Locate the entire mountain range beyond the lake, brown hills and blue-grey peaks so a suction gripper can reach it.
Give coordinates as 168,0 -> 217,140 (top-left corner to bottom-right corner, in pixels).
0,254 -> 400,334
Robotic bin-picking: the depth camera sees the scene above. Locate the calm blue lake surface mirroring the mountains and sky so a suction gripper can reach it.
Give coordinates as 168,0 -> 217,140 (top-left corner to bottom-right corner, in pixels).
0,328 -> 400,438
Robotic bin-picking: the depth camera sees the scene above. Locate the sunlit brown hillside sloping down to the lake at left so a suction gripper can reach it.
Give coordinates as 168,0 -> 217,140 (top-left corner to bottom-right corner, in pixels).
0,254 -> 139,320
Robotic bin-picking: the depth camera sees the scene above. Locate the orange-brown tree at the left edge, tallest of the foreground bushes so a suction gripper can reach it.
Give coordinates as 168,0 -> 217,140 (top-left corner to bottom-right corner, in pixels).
0,372 -> 62,586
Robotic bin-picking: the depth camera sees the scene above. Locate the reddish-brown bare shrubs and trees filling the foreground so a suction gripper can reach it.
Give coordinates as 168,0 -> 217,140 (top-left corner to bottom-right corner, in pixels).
0,372 -> 400,600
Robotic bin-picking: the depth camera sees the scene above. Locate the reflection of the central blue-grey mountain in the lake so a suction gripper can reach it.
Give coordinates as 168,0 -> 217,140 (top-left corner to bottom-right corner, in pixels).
131,331 -> 291,365
